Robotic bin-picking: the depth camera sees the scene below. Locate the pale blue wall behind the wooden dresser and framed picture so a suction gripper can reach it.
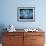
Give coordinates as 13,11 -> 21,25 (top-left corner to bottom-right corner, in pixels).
0,0 -> 46,45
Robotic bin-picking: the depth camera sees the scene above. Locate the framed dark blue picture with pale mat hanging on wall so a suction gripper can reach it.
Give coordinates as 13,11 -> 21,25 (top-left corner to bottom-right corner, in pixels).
17,7 -> 35,22
